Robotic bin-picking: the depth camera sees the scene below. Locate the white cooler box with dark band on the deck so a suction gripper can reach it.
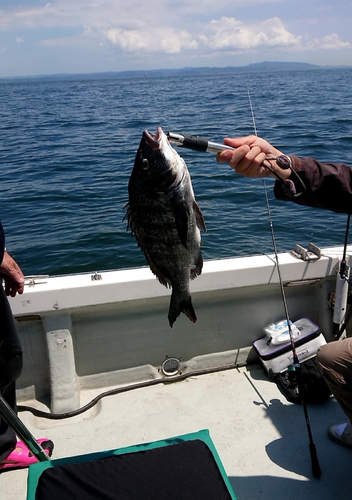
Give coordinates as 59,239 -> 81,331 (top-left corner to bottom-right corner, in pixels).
253,318 -> 326,375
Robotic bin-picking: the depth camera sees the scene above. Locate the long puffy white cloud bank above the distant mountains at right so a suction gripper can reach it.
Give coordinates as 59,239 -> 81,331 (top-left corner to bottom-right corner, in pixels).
103,17 -> 351,54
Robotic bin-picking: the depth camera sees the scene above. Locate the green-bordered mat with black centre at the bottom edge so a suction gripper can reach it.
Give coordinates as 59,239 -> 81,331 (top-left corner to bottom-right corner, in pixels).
27,430 -> 237,500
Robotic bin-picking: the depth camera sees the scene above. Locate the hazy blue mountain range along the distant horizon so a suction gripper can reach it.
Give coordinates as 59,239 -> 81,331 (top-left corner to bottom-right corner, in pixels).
0,61 -> 342,80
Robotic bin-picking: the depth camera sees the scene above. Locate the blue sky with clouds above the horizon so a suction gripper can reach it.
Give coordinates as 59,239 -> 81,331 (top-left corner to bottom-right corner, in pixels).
0,0 -> 352,77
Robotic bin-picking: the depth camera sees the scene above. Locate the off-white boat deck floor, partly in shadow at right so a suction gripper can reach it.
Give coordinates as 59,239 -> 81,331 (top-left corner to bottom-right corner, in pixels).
0,365 -> 352,500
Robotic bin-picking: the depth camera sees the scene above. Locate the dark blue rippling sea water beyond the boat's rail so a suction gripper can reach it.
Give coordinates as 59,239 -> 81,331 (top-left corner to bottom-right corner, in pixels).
0,68 -> 352,275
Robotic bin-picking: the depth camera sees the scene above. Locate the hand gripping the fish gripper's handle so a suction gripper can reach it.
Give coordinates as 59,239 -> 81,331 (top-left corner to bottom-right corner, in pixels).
217,135 -> 291,180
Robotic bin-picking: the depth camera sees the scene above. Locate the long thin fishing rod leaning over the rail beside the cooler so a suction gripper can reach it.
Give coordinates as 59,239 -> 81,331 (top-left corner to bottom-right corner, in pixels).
248,89 -> 321,477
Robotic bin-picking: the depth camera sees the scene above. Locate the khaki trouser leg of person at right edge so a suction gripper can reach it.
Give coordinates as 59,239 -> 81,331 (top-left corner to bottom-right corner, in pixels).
317,338 -> 352,422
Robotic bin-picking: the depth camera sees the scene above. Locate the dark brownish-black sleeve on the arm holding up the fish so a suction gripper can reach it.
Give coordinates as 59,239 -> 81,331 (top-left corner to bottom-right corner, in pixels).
274,156 -> 352,213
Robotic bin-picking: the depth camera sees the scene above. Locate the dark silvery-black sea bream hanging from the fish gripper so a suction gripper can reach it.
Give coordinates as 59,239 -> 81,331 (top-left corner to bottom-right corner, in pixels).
124,127 -> 206,326
